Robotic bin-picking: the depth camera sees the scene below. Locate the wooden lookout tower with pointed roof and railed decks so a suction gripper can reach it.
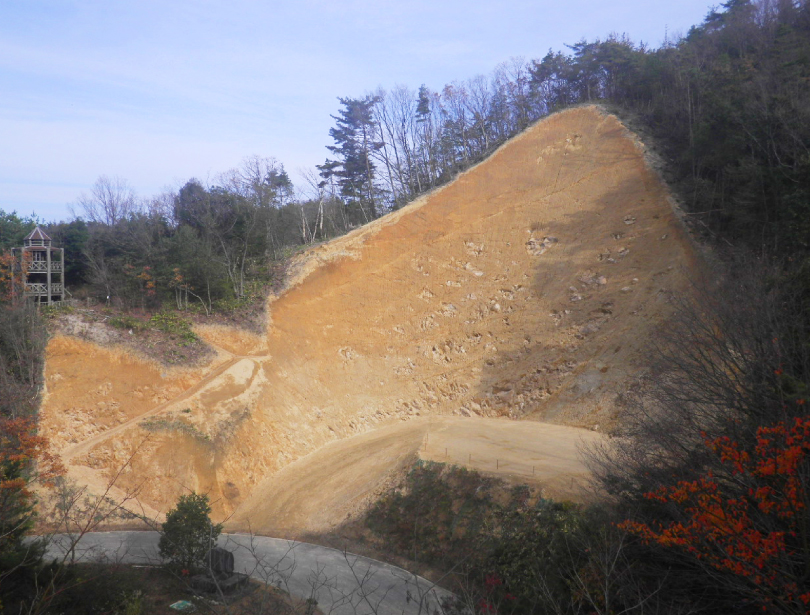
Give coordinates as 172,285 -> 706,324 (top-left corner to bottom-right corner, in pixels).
11,227 -> 65,304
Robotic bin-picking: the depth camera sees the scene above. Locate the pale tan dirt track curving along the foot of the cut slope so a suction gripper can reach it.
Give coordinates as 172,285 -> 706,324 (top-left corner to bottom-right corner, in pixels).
226,417 -> 602,537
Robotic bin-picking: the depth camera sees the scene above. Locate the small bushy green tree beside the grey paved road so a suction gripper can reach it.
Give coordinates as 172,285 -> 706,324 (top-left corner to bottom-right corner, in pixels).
158,491 -> 222,574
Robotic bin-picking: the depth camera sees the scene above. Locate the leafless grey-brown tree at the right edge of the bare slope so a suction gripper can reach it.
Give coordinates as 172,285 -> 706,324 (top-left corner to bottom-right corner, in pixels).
591,260 -> 810,498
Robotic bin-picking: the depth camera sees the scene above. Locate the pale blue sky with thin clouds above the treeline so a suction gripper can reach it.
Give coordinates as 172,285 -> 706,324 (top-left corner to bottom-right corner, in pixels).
0,0 -> 712,220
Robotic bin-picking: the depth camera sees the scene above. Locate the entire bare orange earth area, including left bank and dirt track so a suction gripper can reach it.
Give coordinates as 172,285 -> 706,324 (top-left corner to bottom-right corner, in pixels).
41,107 -> 698,536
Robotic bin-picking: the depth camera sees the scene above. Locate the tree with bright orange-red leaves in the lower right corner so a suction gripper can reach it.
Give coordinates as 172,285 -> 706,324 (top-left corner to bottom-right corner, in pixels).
620,416 -> 810,613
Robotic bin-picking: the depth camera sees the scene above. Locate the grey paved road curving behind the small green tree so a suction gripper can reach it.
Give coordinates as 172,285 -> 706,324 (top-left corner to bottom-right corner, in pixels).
47,532 -> 450,615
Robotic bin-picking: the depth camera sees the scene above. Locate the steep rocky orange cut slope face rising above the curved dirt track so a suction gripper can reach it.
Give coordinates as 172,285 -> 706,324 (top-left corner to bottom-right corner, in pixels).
43,107 -> 694,527
